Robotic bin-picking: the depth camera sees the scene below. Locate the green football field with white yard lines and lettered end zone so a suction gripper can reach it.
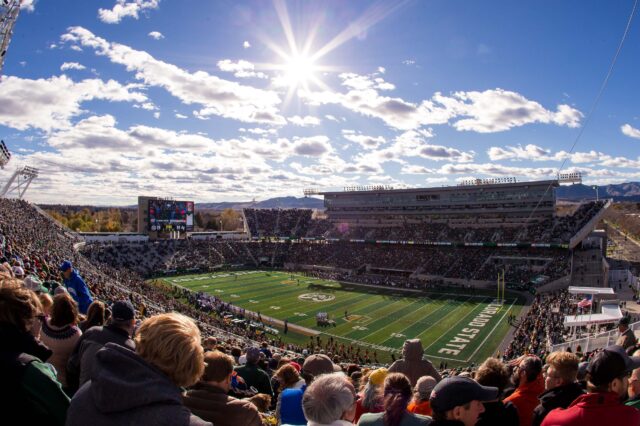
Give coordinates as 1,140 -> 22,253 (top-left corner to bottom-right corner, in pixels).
164,271 -> 524,366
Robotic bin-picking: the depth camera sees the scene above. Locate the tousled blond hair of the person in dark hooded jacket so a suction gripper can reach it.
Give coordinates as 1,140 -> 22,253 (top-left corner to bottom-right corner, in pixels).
135,312 -> 204,386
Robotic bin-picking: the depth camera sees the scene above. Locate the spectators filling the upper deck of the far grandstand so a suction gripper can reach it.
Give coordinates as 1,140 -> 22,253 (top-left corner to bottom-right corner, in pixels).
244,201 -> 605,244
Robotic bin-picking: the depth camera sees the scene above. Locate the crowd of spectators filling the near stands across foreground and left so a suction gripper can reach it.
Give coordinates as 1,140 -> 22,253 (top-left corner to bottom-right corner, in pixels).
0,199 -> 640,426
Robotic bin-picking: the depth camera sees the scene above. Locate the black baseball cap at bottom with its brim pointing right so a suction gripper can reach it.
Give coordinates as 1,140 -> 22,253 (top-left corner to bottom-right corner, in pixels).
429,376 -> 499,413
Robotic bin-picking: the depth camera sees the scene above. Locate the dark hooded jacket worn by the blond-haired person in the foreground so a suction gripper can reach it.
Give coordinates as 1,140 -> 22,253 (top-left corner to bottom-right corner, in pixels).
67,343 -> 211,426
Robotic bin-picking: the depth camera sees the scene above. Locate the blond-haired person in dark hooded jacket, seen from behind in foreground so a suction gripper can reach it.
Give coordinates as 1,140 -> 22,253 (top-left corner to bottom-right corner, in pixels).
67,313 -> 211,426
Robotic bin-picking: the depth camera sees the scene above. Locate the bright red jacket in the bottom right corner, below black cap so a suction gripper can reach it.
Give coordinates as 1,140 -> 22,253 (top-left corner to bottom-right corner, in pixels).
542,392 -> 640,426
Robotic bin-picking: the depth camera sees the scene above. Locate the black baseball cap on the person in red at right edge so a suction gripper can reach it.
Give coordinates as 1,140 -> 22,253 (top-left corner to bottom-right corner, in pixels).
587,345 -> 640,386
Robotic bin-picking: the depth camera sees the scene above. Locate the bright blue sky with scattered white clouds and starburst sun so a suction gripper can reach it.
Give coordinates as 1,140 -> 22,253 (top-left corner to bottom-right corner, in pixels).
0,0 -> 640,205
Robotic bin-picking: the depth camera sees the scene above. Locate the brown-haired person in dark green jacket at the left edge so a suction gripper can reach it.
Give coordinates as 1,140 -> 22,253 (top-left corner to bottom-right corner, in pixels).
0,283 -> 69,426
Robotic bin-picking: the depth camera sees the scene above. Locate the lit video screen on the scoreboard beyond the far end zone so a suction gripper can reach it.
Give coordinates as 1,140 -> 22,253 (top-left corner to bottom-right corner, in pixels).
149,200 -> 194,232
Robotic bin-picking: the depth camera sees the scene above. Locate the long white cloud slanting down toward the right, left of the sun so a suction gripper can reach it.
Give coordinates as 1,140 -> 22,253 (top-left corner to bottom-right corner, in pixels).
62,27 -> 286,125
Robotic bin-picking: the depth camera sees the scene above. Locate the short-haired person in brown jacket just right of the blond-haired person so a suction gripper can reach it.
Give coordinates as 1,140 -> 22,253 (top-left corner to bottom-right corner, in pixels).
183,351 -> 262,426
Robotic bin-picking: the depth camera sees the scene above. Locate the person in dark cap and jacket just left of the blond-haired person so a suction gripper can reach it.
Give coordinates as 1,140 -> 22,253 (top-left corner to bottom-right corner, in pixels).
67,300 -> 136,393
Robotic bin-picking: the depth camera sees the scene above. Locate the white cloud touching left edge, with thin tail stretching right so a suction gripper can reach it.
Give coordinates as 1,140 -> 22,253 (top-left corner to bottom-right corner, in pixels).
0,75 -> 147,132
